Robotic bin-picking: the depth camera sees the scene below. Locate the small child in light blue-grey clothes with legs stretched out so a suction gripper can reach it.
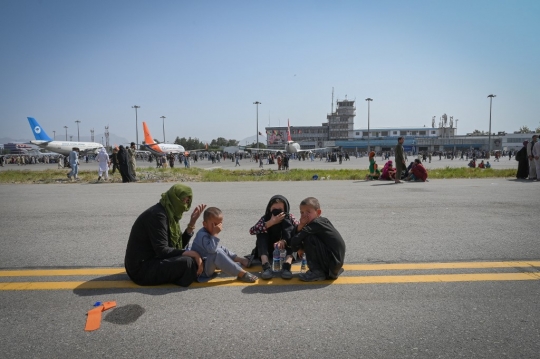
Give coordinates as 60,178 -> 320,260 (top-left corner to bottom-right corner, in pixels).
191,207 -> 259,283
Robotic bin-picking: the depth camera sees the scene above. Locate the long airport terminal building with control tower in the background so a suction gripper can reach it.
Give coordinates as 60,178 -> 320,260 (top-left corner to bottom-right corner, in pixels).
266,99 -> 532,153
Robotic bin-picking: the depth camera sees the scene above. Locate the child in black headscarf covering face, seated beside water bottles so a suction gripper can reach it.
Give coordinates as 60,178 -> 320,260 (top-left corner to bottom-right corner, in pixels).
249,195 -> 298,279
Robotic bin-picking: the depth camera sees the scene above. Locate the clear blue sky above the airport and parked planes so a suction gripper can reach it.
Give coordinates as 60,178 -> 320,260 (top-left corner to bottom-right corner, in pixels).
0,0 -> 540,142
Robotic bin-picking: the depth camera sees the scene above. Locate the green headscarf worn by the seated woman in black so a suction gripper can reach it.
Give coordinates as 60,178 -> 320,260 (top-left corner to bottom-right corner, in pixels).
159,184 -> 193,249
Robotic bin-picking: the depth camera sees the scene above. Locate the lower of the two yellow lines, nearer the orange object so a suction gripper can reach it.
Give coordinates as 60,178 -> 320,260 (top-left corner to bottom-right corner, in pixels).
0,273 -> 540,291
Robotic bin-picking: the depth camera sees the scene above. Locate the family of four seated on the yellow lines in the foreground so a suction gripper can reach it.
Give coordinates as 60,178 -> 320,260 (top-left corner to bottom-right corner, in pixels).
124,184 -> 345,287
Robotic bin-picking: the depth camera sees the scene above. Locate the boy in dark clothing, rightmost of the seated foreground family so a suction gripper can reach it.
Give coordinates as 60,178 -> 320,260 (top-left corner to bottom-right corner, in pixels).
291,197 -> 345,282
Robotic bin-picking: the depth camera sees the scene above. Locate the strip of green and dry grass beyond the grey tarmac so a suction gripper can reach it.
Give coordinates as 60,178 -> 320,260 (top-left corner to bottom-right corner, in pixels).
0,167 -> 516,184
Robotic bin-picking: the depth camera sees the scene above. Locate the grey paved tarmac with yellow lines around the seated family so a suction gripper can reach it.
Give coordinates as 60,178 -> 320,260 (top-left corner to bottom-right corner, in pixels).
0,179 -> 540,358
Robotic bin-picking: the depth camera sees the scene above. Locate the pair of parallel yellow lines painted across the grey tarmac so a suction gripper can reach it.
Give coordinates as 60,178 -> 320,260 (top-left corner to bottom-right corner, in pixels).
0,261 -> 540,291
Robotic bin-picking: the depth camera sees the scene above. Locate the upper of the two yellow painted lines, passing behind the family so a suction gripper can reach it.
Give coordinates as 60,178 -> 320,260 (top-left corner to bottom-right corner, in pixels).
0,261 -> 540,277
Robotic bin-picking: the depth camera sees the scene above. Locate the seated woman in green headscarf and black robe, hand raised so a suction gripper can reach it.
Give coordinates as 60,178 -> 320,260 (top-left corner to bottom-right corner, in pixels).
124,184 -> 206,287
